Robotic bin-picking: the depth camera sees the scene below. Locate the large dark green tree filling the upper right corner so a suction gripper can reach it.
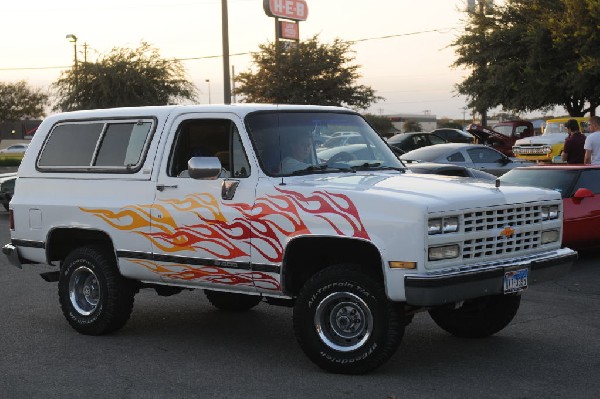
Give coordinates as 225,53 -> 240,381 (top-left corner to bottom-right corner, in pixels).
453,0 -> 600,116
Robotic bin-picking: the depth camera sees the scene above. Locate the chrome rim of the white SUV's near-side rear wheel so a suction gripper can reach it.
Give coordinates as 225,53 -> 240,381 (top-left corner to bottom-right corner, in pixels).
69,266 -> 101,316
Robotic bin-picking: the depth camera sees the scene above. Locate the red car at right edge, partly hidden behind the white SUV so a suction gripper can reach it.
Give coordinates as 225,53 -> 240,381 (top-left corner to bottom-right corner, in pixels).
500,164 -> 600,249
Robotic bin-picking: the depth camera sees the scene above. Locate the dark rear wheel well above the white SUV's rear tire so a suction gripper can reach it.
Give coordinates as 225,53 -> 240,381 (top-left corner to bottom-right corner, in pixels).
46,228 -> 114,262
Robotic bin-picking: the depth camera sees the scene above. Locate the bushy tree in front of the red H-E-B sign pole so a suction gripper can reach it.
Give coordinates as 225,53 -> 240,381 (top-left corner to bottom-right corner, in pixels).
235,35 -> 382,109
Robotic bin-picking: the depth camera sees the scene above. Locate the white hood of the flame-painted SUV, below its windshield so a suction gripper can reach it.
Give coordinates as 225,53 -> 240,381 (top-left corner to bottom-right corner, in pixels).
286,172 -> 560,212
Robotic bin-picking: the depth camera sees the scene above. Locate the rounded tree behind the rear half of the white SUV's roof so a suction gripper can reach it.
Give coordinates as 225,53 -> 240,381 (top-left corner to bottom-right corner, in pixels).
52,42 -> 196,111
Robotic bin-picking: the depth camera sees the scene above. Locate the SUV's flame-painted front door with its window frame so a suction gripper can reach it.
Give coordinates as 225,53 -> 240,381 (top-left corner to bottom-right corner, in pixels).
146,114 -> 257,292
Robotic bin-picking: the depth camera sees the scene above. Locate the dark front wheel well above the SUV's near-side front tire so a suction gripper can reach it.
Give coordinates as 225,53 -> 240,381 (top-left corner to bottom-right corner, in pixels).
281,237 -> 383,296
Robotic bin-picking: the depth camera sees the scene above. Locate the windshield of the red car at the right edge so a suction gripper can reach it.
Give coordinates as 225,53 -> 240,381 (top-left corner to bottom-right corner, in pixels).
499,168 -> 579,198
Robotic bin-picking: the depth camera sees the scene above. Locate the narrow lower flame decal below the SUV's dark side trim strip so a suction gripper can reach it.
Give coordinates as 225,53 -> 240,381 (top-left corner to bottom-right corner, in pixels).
130,259 -> 280,290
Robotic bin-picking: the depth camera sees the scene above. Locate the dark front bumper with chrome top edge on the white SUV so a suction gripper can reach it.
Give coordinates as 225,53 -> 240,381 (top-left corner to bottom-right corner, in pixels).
404,248 -> 577,306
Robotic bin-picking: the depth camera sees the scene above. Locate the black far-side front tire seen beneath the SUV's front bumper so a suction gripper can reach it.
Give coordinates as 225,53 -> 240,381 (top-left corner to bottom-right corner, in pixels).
429,295 -> 521,338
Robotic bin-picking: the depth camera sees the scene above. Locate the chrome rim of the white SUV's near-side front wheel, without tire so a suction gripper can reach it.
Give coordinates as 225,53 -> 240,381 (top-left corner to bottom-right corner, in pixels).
314,292 -> 373,352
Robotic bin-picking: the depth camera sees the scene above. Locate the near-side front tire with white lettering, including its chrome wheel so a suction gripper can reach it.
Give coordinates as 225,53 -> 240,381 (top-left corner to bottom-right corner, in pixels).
294,265 -> 404,374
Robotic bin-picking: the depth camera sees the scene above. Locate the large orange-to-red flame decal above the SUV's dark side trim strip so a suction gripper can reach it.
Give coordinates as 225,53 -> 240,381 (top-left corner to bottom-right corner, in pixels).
81,188 -> 369,268
